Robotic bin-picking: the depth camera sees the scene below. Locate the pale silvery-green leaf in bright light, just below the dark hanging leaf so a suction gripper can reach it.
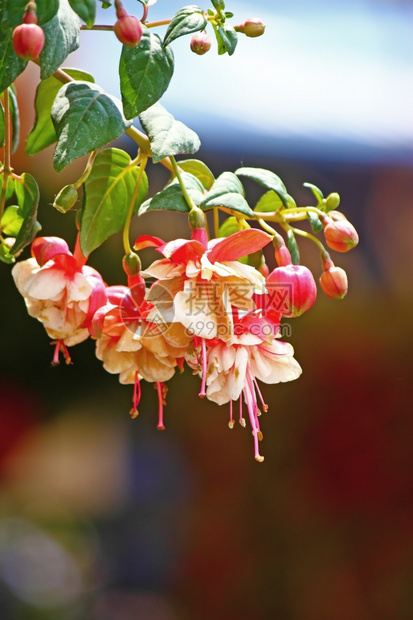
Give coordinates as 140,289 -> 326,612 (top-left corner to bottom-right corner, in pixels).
139,103 -> 201,164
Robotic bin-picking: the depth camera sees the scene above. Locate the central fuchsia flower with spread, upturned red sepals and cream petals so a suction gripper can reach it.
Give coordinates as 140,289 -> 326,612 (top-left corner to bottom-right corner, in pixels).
135,228 -> 271,340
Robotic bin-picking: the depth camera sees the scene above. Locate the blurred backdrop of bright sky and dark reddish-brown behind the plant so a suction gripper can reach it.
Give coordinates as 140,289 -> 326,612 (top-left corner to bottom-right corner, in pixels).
0,0 -> 413,620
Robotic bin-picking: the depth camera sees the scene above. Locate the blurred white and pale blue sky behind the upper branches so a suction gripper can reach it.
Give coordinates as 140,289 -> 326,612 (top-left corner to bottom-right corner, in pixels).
73,0 -> 413,164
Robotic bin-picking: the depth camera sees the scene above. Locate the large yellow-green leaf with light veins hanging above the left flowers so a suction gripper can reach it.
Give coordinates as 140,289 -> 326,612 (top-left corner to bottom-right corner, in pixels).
80,148 -> 148,255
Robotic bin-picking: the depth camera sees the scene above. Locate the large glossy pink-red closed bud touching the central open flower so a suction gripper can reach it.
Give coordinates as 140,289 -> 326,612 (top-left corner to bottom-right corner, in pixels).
266,265 -> 317,318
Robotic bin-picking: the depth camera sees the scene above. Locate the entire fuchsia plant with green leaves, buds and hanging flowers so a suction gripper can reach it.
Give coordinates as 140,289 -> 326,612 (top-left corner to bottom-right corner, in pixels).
0,0 -> 358,461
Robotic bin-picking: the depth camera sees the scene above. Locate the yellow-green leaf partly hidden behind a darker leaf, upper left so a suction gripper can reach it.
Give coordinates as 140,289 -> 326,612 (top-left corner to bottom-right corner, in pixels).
26,69 -> 95,155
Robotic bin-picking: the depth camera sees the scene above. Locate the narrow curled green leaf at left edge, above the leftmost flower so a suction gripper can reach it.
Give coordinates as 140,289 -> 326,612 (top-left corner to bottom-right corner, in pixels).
10,172 -> 41,255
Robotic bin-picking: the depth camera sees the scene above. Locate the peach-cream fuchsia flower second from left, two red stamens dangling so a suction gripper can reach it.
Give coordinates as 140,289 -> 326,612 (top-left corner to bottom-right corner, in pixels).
91,280 -> 190,429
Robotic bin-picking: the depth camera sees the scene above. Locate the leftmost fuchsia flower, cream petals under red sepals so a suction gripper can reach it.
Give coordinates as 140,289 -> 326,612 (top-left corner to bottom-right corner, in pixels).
12,237 -> 106,363
